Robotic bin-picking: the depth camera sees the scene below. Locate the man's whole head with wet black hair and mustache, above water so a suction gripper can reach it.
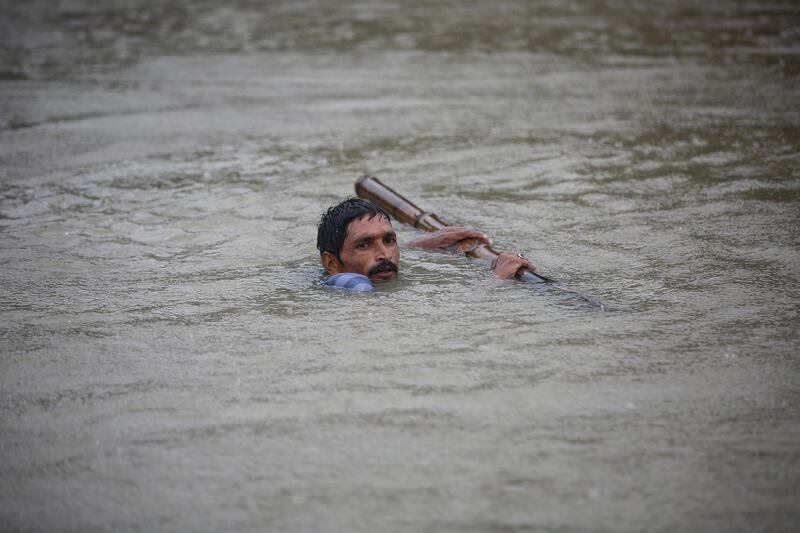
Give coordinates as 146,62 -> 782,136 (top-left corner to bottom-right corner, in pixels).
317,198 -> 400,281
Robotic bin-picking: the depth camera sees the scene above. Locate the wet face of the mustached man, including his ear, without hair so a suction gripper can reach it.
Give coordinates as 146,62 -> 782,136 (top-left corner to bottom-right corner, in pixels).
322,215 -> 400,282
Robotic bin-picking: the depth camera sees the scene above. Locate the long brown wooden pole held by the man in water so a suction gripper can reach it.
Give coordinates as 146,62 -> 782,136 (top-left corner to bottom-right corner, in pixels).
356,176 -> 609,310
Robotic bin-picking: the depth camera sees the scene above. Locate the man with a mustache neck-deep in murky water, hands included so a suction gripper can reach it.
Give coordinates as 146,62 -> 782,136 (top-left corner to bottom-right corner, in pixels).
317,198 -> 534,291
